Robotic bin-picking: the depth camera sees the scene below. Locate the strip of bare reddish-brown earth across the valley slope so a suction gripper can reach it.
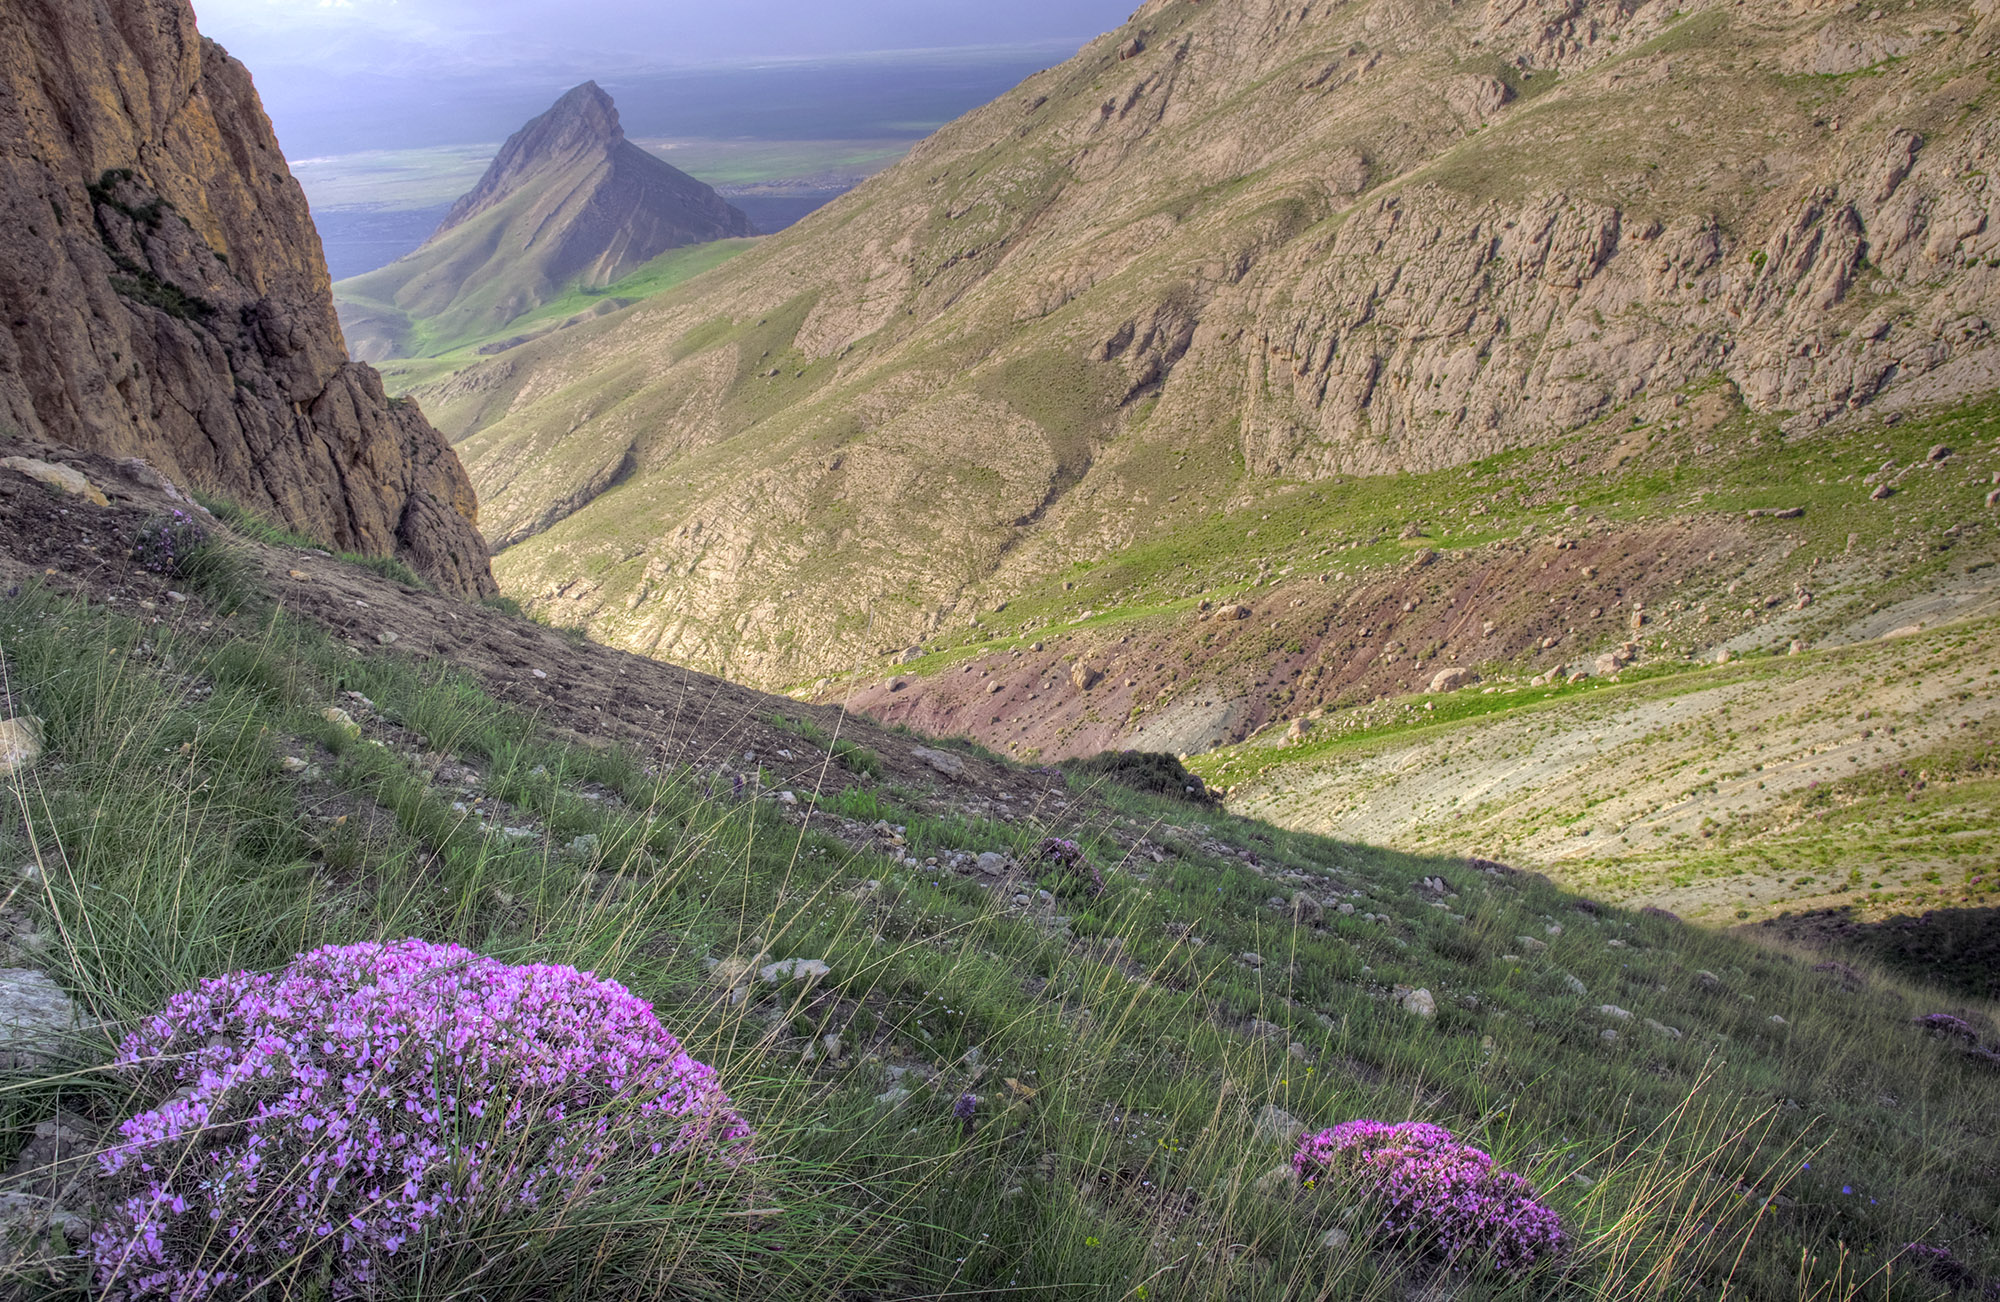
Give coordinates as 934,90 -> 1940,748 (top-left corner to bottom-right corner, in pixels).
848,518 -> 1782,758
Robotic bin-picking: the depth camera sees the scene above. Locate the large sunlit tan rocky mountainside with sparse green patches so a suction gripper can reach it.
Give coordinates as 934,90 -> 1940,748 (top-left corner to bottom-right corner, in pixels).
390,0 -> 2000,684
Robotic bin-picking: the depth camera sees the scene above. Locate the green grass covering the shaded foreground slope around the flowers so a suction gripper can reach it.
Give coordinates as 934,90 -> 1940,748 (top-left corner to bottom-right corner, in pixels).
0,586 -> 2000,1300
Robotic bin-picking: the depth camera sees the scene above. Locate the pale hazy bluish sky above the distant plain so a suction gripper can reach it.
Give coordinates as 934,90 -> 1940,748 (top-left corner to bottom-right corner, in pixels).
194,0 -> 1138,74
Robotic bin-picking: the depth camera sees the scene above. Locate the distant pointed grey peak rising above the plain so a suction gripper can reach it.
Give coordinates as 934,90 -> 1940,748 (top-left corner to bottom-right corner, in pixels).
336,82 -> 752,360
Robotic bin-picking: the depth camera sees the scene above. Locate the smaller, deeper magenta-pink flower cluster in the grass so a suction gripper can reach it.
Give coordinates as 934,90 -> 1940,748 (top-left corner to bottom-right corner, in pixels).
1292,1120 -> 1566,1270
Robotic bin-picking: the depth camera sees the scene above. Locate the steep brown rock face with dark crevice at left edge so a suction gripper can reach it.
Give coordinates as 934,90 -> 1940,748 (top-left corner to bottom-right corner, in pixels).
0,0 -> 496,594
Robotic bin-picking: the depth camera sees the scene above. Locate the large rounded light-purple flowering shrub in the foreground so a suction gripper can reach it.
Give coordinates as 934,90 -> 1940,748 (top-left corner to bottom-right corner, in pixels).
84,940 -> 750,1302
